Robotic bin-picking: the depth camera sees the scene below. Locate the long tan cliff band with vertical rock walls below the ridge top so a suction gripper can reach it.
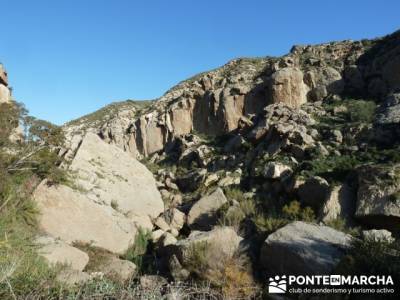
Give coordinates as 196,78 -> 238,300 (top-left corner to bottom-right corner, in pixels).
64,32 -> 400,157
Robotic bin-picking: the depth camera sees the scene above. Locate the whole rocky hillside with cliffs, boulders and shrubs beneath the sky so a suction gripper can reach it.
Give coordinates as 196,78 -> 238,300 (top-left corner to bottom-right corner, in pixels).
0,32 -> 400,299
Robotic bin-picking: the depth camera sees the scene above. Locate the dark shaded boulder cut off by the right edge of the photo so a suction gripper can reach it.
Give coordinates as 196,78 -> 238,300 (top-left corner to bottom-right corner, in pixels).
355,164 -> 400,230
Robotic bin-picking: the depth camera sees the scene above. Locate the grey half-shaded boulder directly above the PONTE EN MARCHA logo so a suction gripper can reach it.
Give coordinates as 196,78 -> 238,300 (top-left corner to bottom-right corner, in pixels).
260,221 -> 352,275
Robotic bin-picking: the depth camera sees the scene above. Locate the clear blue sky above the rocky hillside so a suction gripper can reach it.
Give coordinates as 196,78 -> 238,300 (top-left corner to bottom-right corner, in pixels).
0,0 -> 400,124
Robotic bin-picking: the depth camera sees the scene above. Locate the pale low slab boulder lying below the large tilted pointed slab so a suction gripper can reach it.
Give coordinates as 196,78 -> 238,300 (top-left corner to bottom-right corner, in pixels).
34,182 -> 137,254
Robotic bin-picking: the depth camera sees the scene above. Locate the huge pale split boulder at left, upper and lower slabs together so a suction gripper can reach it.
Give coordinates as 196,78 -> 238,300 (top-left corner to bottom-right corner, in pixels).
34,133 -> 164,254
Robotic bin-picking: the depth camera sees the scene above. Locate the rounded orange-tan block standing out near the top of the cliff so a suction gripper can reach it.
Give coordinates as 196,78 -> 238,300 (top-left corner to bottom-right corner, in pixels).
271,67 -> 308,107
